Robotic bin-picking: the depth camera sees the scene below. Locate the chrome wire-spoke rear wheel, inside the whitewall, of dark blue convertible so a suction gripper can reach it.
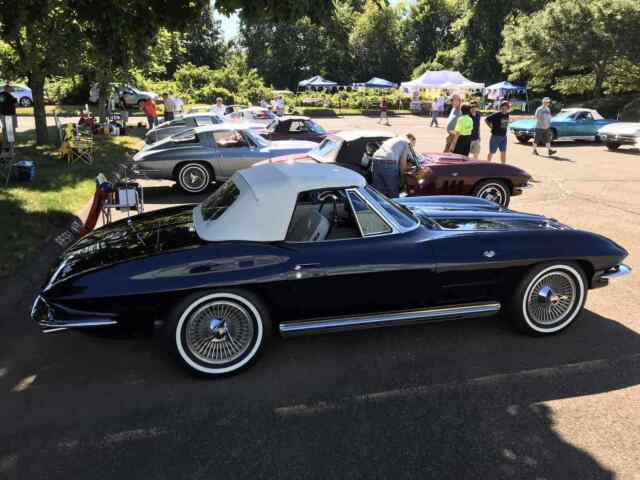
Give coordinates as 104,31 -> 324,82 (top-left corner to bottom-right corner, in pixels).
185,300 -> 255,365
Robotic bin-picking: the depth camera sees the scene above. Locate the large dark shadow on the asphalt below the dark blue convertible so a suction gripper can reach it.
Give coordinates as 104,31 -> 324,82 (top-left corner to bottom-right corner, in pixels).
0,311 -> 640,479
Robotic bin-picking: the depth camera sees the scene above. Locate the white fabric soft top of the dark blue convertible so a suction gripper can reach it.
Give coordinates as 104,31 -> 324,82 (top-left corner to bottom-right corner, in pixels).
193,163 -> 366,242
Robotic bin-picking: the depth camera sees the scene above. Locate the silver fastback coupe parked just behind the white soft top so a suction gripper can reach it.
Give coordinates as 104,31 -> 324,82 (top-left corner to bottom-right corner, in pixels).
128,123 -> 316,193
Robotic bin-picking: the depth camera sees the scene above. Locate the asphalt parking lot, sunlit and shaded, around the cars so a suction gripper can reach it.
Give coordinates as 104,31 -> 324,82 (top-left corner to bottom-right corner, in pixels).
0,116 -> 640,479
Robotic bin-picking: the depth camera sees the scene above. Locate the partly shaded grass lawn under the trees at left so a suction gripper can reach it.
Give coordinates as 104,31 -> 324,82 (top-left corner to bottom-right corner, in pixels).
0,128 -> 144,277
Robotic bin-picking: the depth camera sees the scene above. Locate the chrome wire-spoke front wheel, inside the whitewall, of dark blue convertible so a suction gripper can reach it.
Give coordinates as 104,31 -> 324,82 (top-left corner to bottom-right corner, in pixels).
526,270 -> 578,327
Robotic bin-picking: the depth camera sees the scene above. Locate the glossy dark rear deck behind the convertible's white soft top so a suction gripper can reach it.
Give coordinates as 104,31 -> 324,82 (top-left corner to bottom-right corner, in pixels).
48,205 -> 203,284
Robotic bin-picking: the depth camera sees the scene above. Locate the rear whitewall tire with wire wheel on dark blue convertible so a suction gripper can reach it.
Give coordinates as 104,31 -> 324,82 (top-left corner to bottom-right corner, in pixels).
167,290 -> 271,376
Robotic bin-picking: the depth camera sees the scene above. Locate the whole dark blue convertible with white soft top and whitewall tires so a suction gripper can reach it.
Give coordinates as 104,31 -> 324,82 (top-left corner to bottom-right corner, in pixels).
31,164 -> 630,376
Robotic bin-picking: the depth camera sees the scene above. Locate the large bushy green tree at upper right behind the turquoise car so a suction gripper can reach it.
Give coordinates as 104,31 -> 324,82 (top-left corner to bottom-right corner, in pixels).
499,0 -> 640,98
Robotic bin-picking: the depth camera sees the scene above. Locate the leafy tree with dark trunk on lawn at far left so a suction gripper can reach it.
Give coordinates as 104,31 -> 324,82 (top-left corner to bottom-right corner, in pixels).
0,0 -> 84,144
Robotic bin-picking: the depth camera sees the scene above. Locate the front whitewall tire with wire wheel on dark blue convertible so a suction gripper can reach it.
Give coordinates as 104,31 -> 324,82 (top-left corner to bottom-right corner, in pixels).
507,262 -> 588,335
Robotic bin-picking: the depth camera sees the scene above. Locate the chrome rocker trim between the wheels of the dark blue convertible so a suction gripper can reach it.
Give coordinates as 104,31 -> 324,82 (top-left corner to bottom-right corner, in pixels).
279,302 -> 500,337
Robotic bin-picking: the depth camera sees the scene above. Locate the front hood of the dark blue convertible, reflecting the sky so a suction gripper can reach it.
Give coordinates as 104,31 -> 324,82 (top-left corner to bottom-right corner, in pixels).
397,195 -> 570,231
